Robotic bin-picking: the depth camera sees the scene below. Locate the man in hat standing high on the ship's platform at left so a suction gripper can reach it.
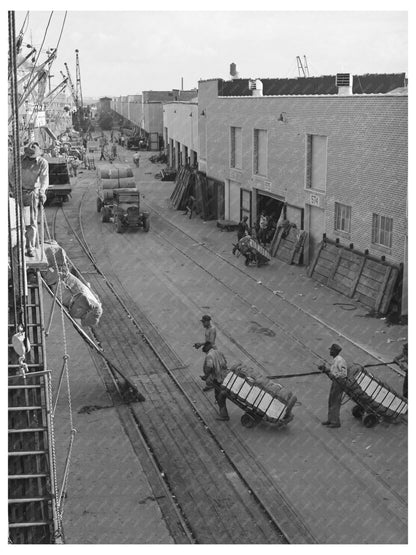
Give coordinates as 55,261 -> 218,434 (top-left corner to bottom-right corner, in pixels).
21,142 -> 49,256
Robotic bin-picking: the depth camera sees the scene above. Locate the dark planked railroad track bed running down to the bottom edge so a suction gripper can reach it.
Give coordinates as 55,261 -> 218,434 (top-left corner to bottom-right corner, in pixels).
44,181 -> 315,544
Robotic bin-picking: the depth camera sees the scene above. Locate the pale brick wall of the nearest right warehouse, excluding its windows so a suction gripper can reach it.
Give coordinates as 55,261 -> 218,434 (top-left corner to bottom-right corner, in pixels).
198,80 -> 408,263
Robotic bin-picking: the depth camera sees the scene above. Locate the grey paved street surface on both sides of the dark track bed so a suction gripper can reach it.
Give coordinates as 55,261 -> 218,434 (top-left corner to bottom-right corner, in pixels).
49,149 -> 407,543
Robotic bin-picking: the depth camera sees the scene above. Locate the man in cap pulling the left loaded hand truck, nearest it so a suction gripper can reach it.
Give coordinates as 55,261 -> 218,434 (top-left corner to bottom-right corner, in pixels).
201,341 -> 230,421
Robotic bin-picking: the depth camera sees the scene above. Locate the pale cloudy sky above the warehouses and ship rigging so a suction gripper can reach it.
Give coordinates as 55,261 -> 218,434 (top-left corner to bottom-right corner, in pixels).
10,0 -> 408,98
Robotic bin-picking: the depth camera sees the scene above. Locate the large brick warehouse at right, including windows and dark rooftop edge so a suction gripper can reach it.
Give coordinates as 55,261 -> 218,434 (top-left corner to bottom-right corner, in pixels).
198,76 -> 408,280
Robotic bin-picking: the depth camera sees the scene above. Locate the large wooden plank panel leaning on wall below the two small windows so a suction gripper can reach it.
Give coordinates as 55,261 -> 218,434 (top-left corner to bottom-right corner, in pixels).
308,239 -> 400,314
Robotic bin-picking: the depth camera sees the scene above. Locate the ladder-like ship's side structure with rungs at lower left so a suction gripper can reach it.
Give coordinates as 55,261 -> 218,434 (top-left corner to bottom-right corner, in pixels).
8,270 -> 63,544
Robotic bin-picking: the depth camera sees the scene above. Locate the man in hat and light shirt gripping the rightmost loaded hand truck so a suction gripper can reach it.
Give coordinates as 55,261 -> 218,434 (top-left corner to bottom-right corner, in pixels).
319,343 -> 347,428
